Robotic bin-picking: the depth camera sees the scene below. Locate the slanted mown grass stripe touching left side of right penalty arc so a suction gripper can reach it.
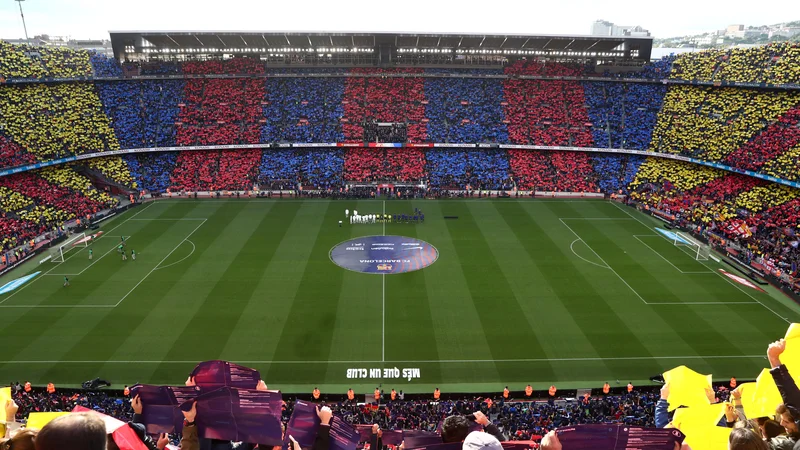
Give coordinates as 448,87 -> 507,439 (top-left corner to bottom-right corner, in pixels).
497,202 -> 660,378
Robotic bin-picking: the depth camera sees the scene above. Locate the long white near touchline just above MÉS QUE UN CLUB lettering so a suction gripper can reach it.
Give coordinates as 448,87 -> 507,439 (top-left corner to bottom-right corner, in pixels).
3,355 -> 766,364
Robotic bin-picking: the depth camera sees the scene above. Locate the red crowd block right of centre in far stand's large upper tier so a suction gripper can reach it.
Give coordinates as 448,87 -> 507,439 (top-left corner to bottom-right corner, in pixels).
503,61 -> 592,147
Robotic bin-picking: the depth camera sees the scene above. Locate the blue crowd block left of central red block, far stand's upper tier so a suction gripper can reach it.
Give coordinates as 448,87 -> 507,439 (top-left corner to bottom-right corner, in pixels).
261,77 -> 345,142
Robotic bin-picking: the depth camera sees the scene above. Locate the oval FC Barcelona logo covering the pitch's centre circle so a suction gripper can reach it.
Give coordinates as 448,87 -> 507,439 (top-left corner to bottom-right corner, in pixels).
330,236 -> 439,274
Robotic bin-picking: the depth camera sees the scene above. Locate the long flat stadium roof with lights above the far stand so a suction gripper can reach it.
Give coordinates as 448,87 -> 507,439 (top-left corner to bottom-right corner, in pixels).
110,31 -> 653,61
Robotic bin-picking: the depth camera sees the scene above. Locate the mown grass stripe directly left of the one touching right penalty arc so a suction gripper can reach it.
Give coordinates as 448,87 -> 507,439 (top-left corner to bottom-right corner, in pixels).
468,203 -> 598,382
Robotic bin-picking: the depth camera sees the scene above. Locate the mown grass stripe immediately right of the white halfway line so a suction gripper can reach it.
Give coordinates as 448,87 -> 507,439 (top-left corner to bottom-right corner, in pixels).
381,201 -> 444,383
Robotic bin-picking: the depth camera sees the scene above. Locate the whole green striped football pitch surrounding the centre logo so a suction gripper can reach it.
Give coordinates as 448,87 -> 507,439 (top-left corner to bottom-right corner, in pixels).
0,199 -> 800,393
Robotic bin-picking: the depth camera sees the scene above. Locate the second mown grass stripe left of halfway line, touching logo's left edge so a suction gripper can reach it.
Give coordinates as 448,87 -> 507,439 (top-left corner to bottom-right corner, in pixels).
267,203 -> 346,384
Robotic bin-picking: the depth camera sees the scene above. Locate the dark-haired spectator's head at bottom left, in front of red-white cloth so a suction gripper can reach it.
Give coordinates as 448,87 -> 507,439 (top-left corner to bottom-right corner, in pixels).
36,413 -> 106,450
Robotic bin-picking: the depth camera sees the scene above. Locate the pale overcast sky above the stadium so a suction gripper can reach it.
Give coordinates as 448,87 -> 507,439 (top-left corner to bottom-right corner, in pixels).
0,0 -> 800,39
